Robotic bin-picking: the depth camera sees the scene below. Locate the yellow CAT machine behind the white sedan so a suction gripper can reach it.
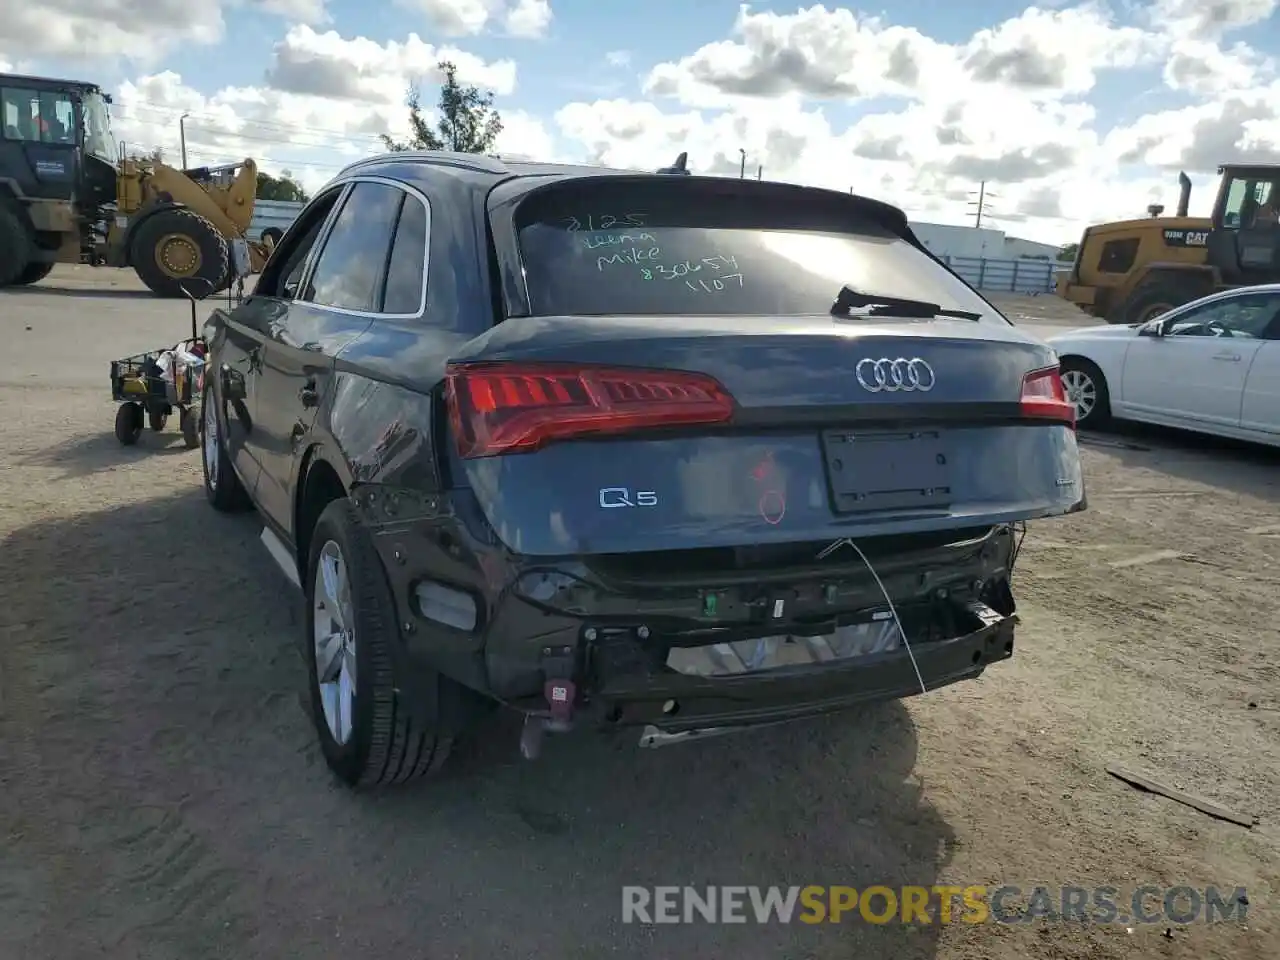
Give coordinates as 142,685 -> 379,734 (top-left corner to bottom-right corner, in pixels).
1057,164 -> 1280,324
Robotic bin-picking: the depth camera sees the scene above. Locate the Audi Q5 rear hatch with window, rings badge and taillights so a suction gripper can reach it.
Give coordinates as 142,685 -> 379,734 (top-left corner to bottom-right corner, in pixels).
447,177 -> 1083,556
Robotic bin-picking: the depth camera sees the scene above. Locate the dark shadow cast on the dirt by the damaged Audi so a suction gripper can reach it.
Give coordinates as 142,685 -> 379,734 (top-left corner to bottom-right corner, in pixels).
0,492 -> 954,960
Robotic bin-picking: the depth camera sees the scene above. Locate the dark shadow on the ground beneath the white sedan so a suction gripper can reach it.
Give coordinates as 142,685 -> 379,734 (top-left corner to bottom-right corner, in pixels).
1080,422 -> 1280,502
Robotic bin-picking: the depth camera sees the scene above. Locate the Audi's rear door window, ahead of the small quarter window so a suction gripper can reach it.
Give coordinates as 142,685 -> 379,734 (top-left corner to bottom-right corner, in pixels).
300,183 -> 404,312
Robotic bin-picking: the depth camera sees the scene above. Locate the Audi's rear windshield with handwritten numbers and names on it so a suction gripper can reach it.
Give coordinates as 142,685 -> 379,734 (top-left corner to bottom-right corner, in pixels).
516,179 -> 1005,325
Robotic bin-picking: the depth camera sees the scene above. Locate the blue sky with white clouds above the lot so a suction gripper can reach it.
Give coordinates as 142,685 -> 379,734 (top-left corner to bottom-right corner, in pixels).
0,0 -> 1280,241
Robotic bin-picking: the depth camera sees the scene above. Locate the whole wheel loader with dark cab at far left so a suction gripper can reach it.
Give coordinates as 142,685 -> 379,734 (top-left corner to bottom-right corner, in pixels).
0,74 -> 271,298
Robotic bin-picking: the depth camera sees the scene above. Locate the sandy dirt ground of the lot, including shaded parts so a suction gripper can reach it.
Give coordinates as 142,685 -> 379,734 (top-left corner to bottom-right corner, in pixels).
0,268 -> 1280,960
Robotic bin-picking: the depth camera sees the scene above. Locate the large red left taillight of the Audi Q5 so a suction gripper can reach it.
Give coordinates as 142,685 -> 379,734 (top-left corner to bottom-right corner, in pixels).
445,362 -> 733,457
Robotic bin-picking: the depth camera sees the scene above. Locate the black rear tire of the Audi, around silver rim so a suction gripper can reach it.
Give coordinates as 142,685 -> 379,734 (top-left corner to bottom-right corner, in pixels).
303,497 -> 453,787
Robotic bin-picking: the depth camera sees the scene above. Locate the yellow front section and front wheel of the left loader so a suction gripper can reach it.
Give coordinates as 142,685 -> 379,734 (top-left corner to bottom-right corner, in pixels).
102,157 -> 271,298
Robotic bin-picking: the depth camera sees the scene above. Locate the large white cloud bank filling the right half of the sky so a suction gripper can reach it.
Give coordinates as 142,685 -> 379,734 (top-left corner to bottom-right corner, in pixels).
556,0 -> 1280,242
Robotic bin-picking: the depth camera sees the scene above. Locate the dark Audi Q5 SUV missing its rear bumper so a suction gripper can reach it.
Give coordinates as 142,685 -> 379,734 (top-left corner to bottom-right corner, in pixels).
202,152 -> 1084,785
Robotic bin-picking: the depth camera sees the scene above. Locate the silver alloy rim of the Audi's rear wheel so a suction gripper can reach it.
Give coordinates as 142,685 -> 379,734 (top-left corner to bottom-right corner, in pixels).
311,540 -> 356,745
